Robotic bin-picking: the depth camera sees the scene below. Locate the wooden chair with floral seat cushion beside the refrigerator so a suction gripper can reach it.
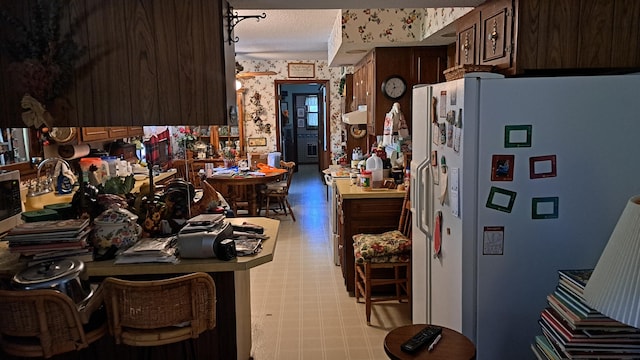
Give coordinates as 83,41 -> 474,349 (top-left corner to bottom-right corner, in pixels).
353,189 -> 411,325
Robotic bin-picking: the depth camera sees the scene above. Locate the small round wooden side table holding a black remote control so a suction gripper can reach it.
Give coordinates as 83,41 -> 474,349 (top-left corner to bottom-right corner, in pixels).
384,324 -> 476,360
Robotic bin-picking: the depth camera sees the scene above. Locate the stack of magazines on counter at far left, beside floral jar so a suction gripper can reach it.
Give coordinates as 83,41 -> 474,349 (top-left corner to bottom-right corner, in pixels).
4,219 -> 93,266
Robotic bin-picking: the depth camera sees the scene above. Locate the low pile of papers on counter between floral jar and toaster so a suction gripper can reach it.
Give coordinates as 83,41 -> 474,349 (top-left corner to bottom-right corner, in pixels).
115,236 -> 179,264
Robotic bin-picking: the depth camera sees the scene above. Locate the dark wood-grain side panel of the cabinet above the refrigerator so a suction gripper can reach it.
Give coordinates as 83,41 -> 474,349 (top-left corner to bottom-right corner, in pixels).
514,0 -> 640,73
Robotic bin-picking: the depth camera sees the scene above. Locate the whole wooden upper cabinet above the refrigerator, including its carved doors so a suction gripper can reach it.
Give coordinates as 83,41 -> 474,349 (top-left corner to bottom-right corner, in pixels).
456,0 -> 640,75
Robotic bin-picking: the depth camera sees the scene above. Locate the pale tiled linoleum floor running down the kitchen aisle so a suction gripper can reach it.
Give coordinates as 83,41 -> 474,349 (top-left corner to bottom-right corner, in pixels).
250,164 -> 411,360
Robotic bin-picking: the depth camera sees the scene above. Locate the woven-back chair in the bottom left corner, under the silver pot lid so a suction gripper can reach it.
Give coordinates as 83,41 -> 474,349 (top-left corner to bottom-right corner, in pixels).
0,289 -> 107,358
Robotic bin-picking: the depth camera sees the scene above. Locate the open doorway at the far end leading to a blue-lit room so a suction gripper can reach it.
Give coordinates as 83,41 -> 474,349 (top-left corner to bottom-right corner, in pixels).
275,80 -> 331,170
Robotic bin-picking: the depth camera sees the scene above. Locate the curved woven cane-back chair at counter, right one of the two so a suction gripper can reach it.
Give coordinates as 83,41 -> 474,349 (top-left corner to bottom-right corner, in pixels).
102,272 -> 216,359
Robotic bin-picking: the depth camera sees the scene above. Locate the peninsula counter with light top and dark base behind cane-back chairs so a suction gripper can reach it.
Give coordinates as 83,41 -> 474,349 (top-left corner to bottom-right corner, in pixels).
0,217 -> 280,360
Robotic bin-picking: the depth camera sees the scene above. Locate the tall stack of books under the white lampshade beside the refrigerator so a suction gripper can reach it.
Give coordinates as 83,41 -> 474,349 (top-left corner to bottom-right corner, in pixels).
531,270 -> 640,360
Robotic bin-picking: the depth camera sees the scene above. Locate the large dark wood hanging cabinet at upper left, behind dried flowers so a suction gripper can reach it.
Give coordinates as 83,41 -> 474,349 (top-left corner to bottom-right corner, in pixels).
0,0 -> 235,126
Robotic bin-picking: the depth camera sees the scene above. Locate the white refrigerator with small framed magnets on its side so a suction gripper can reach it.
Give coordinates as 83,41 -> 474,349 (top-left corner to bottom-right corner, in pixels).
411,74 -> 640,360
